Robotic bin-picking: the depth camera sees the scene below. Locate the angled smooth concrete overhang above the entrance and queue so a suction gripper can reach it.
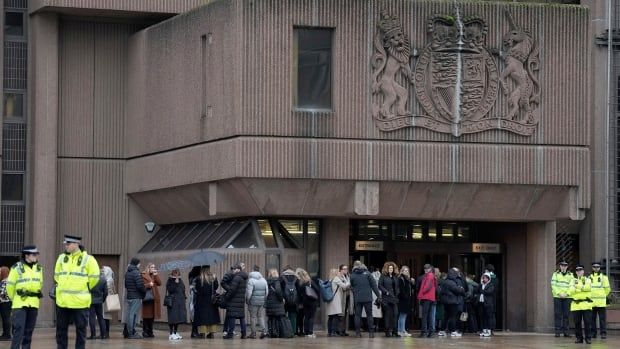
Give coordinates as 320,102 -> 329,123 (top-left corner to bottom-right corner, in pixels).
129,178 -> 583,224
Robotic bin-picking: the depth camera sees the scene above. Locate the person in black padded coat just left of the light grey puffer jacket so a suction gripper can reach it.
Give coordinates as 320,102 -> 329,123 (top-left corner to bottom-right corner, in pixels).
224,263 -> 248,339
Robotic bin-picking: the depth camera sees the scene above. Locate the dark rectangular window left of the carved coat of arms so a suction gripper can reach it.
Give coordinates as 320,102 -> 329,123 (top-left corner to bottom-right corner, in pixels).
293,29 -> 332,109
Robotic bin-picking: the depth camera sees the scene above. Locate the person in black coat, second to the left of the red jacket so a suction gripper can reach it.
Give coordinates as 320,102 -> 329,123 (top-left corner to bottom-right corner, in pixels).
377,262 -> 400,337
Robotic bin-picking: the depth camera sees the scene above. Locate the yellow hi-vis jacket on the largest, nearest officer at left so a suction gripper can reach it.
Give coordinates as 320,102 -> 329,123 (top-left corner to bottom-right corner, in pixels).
54,250 -> 100,309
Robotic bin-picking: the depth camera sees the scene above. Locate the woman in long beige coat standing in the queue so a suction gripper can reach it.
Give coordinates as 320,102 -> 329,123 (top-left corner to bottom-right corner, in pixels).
325,265 -> 351,337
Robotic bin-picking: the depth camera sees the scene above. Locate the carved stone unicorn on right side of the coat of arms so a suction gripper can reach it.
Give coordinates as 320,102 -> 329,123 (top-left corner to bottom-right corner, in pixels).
500,11 -> 540,123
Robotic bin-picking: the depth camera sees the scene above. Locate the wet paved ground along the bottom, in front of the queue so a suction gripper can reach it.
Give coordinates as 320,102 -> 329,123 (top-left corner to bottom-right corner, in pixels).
8,328 -> 620,349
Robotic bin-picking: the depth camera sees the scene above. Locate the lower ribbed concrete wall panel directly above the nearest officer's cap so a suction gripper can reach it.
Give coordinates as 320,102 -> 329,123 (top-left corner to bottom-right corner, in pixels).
57,160 -> 95,241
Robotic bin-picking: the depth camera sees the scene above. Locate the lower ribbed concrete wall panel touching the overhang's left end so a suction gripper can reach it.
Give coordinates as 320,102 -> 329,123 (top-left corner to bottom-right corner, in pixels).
89,161 -> 128,254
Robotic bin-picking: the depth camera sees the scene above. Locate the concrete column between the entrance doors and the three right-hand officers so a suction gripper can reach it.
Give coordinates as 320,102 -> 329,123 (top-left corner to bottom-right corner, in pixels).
524,222 -> 556,332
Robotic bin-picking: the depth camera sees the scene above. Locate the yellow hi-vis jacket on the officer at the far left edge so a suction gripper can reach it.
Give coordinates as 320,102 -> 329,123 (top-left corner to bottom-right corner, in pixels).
6,262 -> 43,309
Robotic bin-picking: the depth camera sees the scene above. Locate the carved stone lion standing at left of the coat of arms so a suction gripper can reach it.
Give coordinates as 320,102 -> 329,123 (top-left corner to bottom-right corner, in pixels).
372,11 -> 413,118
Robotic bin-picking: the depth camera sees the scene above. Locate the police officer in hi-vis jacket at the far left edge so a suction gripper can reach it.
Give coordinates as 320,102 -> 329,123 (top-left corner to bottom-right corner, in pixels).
6,246 -> 43,349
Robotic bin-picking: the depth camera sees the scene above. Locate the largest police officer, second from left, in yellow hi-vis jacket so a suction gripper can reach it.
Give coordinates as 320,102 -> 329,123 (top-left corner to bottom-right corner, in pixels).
54,235 -> 99,349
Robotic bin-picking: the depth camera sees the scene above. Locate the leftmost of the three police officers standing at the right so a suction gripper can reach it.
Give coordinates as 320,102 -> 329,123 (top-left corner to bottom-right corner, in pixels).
551,260 -> 574,337
